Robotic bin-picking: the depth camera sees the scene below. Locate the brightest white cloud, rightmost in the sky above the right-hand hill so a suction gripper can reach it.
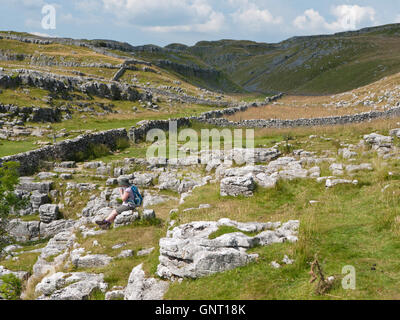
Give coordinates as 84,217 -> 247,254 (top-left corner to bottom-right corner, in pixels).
293,5 -> 376,32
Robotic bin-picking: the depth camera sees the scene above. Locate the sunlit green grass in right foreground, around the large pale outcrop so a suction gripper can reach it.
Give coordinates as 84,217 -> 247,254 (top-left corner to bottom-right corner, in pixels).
166,175 -> 400,300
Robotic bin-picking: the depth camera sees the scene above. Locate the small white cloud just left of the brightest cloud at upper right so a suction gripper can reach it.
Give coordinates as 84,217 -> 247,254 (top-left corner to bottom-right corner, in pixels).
232,1 -> 283,31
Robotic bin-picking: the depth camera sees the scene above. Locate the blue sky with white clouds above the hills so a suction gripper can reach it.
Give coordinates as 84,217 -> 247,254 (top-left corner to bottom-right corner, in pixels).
0,0 -> 400,46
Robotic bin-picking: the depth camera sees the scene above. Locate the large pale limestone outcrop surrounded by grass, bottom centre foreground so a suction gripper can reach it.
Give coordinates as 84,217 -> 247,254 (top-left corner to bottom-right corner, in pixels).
157,219 -> 299,279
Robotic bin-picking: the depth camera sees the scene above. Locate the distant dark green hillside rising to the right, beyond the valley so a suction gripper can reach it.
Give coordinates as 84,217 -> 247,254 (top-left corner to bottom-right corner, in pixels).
130,24 -> 400,94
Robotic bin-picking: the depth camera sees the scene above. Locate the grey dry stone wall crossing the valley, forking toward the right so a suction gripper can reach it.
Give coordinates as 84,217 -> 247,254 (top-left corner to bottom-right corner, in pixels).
0,94 -> 400,175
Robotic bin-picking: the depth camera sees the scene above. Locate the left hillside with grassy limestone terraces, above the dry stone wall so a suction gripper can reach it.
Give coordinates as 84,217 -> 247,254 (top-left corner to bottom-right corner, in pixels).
0,32 -> 236,156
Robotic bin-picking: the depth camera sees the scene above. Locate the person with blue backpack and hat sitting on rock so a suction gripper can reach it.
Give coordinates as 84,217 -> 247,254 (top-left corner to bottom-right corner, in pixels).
96,178 -> 143,230
